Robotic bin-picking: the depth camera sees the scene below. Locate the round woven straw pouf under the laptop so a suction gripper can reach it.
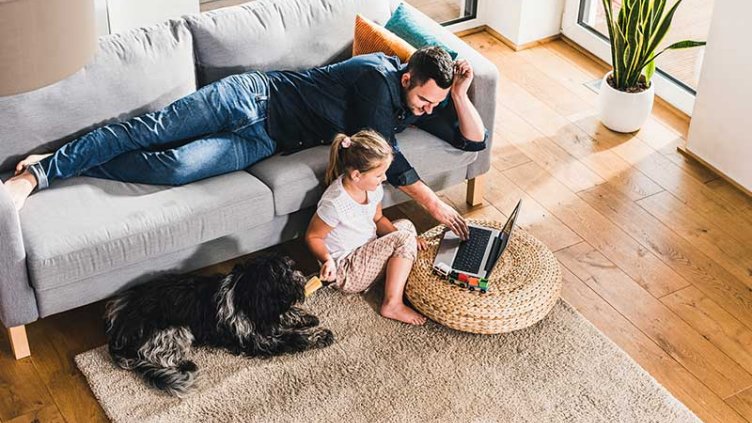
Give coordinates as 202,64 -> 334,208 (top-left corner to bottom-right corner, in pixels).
405,220 -> 561,334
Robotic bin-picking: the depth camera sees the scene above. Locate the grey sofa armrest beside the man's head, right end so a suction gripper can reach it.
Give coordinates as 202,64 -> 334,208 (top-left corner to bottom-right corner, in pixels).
393,3 -> 499,179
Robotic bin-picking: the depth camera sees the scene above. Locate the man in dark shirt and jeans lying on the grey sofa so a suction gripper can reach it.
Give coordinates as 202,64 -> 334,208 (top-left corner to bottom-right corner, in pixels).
5,47 -> 487,238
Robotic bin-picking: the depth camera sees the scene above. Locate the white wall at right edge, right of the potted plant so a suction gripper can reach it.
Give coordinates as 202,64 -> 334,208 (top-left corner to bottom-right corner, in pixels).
687,0 -> 752,191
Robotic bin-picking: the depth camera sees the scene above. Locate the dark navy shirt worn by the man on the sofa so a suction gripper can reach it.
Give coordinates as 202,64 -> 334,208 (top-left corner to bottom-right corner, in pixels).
267,53 -> 488,187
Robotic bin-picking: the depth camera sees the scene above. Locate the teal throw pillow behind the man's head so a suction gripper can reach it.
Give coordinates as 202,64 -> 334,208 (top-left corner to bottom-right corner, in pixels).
384,3 -> 457,60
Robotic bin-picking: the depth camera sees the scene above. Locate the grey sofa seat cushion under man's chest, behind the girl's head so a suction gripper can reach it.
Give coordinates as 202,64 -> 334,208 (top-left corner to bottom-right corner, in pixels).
248,128 -> 478,216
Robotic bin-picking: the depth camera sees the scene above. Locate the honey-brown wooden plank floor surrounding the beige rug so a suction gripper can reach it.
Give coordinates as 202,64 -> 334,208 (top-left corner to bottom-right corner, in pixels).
0,33 -> 752,423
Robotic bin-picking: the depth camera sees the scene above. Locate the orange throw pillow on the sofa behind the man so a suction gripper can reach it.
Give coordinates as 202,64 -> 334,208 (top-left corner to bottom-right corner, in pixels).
353,15 -> 415,63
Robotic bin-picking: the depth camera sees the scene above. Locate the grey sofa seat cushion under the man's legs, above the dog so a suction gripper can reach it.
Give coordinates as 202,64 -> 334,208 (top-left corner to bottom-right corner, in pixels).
20,172 -> 274,291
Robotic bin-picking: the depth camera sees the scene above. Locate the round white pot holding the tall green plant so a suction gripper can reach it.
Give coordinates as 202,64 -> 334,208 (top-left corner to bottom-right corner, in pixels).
598,72 -> 655,132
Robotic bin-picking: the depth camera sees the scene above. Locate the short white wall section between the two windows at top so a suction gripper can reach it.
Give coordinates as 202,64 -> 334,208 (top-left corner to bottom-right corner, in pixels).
478,0 -> 564,46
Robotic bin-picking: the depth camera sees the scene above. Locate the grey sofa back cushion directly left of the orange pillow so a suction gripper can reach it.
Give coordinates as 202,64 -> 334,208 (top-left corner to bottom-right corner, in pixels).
186,0 -> 390,86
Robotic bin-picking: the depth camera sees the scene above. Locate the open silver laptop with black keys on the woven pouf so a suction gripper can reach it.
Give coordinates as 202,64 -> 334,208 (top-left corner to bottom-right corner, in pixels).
433,200 -> 522,279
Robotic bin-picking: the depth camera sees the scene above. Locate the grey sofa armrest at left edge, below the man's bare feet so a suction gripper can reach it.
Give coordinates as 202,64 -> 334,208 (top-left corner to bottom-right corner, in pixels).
0,183 -> 39,328
